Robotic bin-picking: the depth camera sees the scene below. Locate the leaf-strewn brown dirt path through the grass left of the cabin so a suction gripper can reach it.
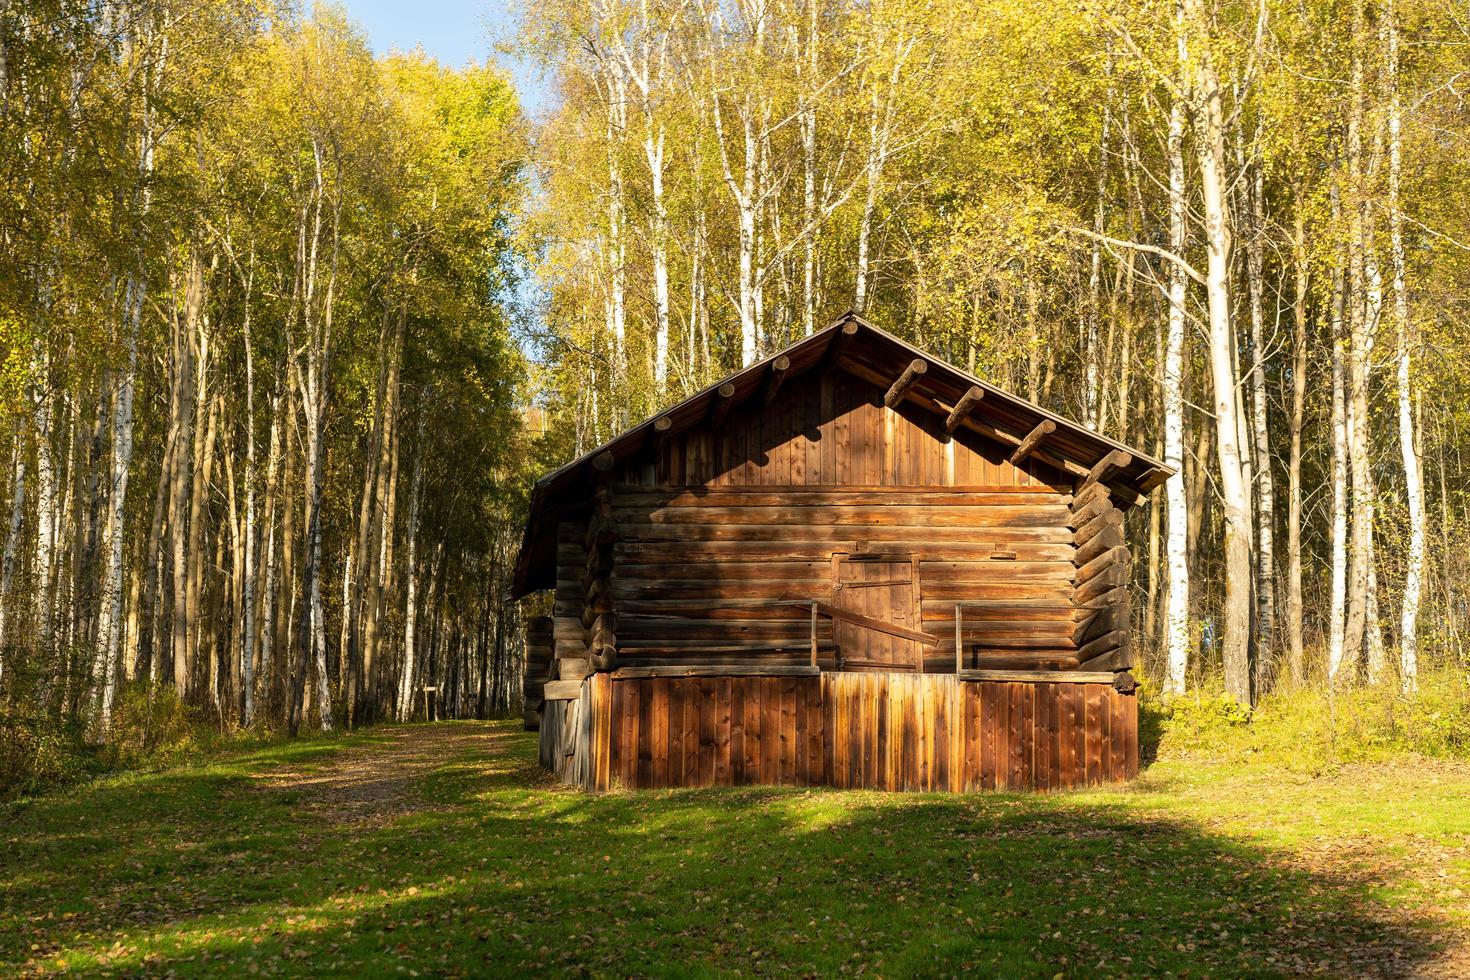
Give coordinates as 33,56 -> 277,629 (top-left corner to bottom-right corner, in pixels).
262,721 -> 526,826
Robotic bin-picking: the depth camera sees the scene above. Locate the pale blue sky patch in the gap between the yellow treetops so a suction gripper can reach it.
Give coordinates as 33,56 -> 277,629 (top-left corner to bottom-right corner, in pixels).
338,0 -> 545,115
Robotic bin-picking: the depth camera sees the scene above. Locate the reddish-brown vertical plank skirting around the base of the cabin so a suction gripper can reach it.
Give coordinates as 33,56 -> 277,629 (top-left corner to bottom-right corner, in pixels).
561,673 -> 1138,792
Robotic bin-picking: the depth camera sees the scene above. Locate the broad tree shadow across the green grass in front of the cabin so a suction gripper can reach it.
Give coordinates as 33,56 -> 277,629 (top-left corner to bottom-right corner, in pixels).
0,719 -> 1444,977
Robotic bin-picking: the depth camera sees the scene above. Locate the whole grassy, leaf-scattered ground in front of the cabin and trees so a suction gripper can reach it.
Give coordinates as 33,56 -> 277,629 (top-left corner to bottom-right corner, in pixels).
0,723 -> 1470,977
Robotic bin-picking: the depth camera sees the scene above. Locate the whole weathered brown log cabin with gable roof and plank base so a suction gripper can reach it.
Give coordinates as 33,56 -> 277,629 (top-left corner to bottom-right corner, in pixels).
515,314 -> 1170,790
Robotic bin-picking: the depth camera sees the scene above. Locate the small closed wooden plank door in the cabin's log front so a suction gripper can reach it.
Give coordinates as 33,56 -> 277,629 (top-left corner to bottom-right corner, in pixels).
832,557 -> 923,670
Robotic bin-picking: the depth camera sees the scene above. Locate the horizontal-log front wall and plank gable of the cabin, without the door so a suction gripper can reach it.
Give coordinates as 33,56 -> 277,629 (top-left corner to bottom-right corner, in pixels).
556,370 -> 1078,676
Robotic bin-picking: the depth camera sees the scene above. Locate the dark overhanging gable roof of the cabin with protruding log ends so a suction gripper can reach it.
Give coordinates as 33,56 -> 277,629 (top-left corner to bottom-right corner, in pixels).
512,313 -> 1173,598
